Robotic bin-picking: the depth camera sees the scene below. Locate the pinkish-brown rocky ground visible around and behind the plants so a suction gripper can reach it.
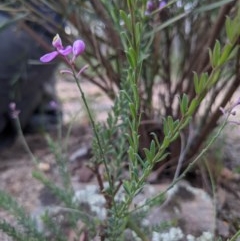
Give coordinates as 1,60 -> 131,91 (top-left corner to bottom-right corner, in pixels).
0,76 -> 240,241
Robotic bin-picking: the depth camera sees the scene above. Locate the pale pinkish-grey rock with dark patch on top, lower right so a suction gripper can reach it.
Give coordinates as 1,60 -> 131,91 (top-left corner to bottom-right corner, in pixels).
148,181 -> 215,237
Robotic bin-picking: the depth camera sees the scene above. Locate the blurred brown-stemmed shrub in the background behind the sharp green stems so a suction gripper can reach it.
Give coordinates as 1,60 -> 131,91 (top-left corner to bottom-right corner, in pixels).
0,0 -> 240,176
